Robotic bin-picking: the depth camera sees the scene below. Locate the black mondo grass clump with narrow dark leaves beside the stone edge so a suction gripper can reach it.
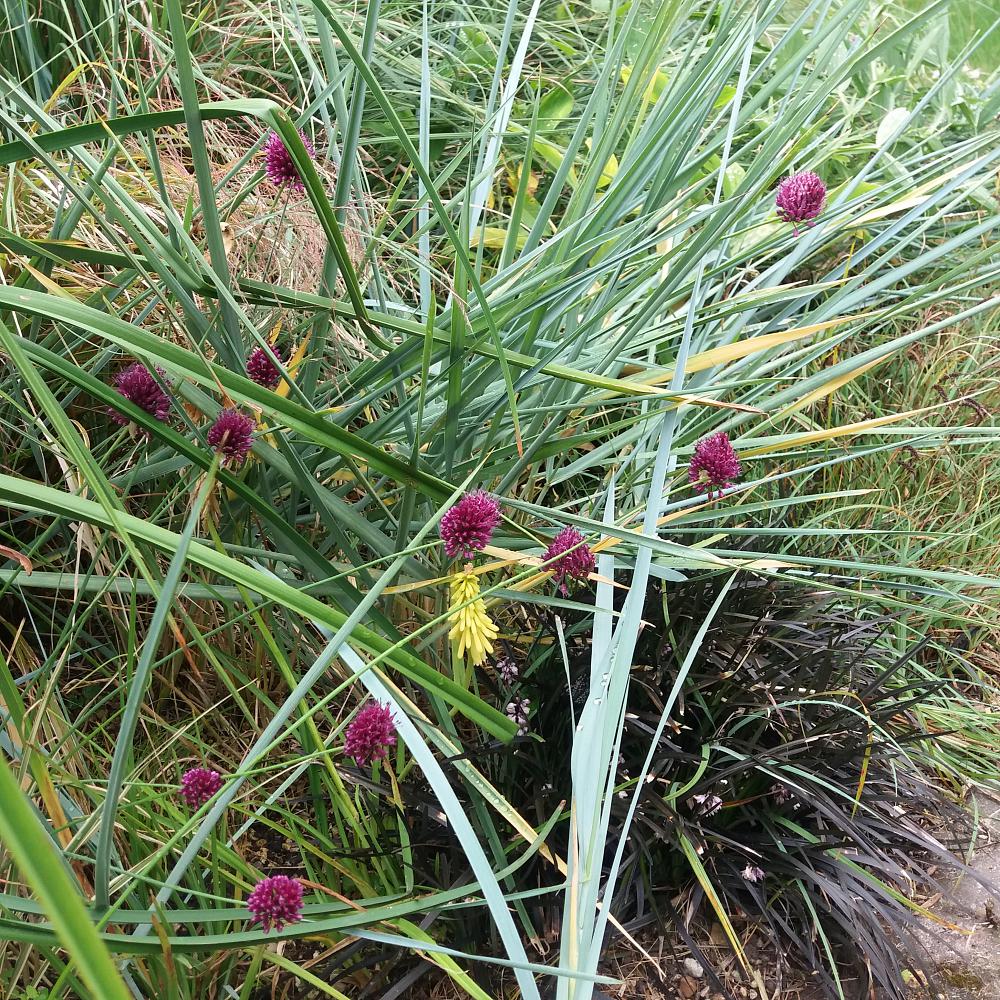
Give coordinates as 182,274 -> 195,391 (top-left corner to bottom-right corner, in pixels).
508,575 -> 980,998
